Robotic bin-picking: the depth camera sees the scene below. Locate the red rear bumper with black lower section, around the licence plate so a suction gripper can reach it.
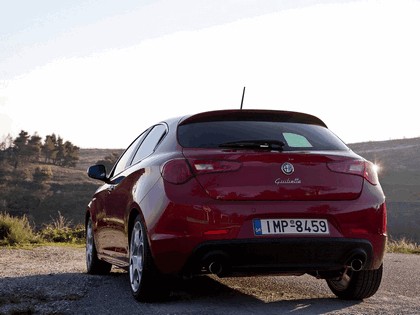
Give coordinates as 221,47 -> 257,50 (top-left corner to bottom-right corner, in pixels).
142,178 -> 386,274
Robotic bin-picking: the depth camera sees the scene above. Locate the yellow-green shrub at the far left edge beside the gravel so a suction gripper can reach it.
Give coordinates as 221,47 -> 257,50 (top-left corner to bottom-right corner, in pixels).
0,212 -> 40,246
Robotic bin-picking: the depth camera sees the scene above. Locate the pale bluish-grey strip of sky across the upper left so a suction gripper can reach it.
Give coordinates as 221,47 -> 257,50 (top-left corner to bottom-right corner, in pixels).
0,0 -> 358,78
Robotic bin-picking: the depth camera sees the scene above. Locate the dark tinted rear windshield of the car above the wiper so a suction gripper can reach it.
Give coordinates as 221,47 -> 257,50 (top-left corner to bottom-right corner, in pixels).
178,121 -> 349,151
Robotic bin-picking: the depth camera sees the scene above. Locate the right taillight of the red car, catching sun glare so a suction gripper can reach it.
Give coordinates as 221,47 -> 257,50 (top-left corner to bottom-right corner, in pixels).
327,160 -> 379,185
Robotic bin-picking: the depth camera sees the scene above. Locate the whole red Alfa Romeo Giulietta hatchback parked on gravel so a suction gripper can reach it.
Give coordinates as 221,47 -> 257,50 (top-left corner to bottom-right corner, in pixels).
86,110 -> 387,301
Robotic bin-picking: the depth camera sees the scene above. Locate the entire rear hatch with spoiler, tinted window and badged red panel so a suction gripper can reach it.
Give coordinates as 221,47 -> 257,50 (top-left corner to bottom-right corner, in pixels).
178,110 -> 366,201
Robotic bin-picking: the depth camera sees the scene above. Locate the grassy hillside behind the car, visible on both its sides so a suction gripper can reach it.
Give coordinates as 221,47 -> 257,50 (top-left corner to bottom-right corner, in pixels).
0,138 -> 420,242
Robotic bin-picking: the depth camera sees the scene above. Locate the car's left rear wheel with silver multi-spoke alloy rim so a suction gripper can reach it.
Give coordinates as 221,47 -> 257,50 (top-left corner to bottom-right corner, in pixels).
128,216 -> 169,302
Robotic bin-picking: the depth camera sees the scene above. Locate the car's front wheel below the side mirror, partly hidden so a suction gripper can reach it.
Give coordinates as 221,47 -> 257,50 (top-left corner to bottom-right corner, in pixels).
86,218 -> 112,275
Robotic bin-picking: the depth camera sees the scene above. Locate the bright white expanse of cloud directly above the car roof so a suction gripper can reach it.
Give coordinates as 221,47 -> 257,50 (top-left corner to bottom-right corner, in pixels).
3,1 -> 420,148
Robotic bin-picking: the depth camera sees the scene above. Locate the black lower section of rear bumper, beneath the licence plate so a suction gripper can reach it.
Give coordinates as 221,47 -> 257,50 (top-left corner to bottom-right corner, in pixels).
184,238 -> 373,275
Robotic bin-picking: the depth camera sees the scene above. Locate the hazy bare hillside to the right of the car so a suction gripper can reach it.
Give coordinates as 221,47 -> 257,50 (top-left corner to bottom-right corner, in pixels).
349,138 -> 420,242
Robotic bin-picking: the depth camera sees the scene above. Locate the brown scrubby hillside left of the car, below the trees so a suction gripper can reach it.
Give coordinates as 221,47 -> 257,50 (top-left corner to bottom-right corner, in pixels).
0,149 -> 122,228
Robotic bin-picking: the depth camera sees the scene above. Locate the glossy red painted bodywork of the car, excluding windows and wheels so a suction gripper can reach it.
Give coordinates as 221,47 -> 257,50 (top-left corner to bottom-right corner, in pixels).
86,110 -> 386,280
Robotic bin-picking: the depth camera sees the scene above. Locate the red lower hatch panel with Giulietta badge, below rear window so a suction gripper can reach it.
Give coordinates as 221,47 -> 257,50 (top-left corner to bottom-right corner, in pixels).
184,149 -> 363,200
